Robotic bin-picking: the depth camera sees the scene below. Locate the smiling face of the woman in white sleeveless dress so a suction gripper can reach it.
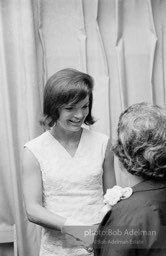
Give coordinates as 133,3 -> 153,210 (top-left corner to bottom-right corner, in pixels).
56,96 -> 89,132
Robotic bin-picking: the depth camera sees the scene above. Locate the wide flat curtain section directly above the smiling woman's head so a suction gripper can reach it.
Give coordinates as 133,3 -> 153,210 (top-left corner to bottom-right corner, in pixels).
39,0 -> 87,78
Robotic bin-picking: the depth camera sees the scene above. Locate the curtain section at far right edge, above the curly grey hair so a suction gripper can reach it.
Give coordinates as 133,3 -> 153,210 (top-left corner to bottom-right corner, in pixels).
149,0 -> 166,107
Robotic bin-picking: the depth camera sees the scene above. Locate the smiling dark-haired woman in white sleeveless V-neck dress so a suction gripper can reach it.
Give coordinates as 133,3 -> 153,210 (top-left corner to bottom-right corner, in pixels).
23,69 -> 115,256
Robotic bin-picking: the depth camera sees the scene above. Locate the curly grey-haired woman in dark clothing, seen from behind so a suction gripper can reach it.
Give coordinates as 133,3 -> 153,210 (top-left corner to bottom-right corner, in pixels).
94,103 -> 166,256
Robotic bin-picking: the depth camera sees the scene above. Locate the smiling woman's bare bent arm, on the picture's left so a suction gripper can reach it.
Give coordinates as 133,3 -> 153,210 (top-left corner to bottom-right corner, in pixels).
23,148 -> 66,230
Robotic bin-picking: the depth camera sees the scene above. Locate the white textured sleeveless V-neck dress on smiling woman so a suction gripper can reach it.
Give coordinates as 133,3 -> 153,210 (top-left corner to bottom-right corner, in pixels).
25,128 -> 108,256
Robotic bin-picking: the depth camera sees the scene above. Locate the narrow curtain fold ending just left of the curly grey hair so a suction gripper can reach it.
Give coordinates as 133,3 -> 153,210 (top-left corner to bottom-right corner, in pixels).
97,0 -> 122,139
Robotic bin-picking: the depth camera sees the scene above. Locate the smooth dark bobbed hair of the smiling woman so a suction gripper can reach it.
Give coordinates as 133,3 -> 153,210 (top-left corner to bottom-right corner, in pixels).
40,68 -> 95,127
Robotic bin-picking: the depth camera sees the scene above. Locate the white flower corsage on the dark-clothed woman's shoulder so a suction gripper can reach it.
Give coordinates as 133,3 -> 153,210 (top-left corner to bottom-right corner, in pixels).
102,186 -> 133,213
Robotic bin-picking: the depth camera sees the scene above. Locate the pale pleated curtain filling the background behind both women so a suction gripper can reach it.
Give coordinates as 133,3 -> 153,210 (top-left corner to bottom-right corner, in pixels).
0,0 -> 166,256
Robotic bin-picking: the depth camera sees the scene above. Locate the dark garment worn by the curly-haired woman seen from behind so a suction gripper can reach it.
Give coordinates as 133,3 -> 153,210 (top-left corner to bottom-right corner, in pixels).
94,181 -> 166,256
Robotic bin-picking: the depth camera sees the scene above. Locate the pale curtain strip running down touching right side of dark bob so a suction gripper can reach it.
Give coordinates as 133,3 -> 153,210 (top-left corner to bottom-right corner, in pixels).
83,0 -> 110,135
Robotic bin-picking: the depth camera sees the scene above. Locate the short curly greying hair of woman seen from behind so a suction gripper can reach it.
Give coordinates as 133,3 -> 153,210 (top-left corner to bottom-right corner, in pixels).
113,102 -> 166,180
